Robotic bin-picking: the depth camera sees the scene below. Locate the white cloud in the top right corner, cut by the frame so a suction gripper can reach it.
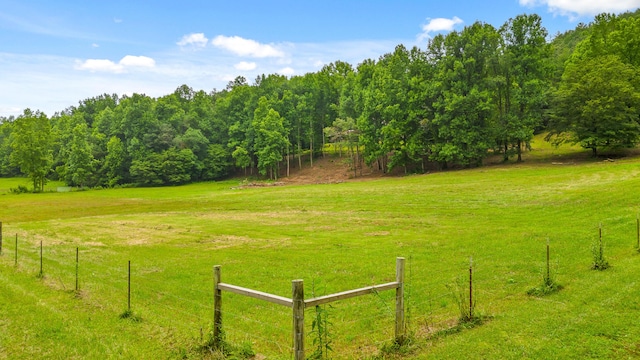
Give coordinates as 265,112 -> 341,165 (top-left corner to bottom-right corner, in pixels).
519,0 -> 640,18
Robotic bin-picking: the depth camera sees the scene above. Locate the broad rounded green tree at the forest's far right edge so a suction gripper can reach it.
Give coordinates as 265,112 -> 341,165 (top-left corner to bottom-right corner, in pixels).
549,55 -> 640,156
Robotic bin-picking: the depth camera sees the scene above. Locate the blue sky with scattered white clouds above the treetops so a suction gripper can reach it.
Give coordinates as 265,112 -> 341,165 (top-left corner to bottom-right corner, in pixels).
0,0 -> 640,116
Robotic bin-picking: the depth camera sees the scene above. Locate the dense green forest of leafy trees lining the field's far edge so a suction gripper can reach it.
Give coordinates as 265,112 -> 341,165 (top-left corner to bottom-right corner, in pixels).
0,11 -> 640,191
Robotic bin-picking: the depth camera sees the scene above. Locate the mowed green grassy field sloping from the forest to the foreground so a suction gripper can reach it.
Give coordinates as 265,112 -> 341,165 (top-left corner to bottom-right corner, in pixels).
0,144 -> 640,359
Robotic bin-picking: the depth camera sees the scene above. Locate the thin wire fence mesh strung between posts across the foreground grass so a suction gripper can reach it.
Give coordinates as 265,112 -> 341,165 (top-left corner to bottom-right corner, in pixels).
0,218 -> 635,358
